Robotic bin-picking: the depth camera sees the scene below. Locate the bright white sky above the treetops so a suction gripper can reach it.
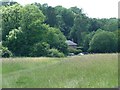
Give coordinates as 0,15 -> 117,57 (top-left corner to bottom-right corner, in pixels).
9,0 -> 119,18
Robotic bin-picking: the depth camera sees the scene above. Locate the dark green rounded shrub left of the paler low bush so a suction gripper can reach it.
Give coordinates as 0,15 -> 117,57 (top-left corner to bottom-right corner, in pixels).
30,42 -> 50,57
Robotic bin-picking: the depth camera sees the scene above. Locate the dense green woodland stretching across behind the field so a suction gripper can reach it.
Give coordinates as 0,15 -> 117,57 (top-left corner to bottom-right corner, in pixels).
0,2 -> 120,57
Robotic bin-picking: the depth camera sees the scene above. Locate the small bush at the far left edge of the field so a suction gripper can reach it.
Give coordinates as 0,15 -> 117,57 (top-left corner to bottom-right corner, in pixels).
0,46 -> 13,57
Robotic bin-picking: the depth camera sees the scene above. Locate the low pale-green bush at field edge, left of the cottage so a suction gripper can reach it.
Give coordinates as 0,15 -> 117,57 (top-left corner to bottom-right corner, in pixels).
48,48 -> 64,57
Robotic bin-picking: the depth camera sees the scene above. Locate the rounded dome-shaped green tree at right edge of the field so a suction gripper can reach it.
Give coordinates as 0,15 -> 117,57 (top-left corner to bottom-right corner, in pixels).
89,31 -> 117,53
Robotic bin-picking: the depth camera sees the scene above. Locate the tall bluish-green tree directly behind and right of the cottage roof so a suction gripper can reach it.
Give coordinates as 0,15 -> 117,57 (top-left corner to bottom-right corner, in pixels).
70,14 -> 89,45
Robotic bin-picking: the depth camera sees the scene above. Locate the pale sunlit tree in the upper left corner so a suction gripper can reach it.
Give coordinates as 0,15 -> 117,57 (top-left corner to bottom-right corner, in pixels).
1,4 -> 22,40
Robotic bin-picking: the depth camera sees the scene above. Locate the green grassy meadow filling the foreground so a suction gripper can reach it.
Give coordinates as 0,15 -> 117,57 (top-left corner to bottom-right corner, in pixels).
2,54 -> 118,88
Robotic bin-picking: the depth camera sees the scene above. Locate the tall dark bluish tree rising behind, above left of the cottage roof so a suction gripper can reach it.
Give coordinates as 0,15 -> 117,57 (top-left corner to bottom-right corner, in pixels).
55,6 -> 74,39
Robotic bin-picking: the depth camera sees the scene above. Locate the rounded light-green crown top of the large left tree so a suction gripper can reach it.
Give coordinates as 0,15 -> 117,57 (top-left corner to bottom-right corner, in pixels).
21,5 -> 45,29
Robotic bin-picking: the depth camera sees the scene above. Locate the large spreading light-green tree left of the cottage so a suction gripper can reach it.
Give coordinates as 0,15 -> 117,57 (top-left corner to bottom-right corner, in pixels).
7,5 -> 67,56
